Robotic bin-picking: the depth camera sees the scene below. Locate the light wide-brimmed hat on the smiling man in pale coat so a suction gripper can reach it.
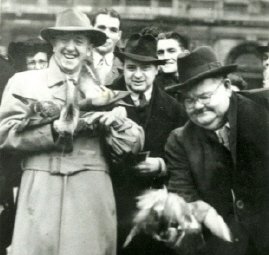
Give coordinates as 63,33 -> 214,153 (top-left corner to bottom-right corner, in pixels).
40,8 -> 107,47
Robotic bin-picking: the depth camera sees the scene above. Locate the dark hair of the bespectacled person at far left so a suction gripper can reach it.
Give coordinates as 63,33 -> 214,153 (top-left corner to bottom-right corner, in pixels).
8,38 -> 52,72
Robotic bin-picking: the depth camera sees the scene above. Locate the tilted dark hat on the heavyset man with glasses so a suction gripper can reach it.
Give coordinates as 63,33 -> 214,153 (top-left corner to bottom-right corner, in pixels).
165,46 -> 237,91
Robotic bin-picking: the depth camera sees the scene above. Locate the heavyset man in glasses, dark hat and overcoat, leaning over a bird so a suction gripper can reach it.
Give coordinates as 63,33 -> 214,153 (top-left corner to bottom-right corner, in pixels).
165,46 -> 269,255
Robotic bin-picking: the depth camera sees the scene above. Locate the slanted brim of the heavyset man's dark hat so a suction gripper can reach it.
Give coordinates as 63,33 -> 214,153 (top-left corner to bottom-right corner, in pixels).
165,65 -> 238,92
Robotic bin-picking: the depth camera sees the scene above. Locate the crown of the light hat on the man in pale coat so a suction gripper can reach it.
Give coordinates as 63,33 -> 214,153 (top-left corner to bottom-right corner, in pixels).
55,8 -> 92,29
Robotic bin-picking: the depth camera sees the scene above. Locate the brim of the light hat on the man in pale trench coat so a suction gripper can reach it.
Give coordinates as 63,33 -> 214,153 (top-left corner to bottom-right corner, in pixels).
40,27 -> 107,47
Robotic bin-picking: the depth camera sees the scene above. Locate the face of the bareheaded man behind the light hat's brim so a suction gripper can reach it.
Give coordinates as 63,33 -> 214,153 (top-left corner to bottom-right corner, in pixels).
94,14 -> 121,55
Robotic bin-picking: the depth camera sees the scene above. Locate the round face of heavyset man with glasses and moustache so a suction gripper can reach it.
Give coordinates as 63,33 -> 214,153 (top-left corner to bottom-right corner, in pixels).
184,78 -> 232,130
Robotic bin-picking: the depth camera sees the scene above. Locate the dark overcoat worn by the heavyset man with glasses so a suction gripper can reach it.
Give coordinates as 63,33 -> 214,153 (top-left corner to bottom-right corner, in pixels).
166,94 -> 269,254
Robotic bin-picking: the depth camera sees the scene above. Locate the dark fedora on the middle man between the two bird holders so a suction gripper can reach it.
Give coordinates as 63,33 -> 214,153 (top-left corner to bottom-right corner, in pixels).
114,34 -> 166,65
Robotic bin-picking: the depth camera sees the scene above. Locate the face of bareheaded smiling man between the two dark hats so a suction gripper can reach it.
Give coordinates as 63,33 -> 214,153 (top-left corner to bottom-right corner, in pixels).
157,39 -> 184,73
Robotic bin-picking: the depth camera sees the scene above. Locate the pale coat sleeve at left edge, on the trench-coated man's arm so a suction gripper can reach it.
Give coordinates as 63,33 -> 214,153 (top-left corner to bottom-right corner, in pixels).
0,75 -> 55,152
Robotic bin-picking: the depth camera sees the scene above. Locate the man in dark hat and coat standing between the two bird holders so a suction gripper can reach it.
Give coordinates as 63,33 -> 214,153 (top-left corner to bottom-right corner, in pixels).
112,34 -> 186,254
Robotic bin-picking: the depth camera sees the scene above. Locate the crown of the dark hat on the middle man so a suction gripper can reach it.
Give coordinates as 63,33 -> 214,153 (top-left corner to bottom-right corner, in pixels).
124,34 -> 157,60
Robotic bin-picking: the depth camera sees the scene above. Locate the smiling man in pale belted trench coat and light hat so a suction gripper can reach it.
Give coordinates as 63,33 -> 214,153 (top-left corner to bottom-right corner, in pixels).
0,9 -> 143,255
